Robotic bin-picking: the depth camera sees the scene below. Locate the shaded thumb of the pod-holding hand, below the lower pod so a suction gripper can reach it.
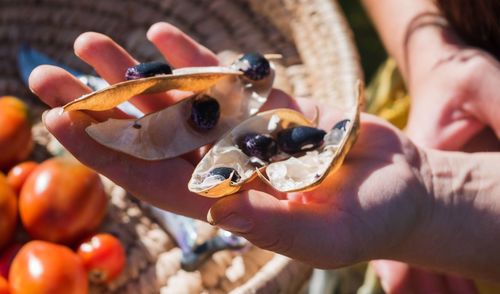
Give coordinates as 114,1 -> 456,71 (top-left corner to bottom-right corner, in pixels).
207,190 -> 356,267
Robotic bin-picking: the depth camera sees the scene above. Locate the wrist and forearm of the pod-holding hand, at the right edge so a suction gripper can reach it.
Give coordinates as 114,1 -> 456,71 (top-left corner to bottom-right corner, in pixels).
400,151 -> 500,279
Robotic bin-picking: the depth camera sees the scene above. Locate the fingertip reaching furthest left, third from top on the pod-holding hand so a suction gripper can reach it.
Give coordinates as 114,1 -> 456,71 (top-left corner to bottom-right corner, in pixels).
29,65 -> 128,120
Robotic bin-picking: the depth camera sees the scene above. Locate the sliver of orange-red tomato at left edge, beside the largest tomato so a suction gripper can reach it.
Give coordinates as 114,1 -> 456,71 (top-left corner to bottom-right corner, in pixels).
0,175 -> 17,250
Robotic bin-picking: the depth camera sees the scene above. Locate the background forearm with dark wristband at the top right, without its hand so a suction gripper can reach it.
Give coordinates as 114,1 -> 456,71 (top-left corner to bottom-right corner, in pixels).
363,0 -> 454,84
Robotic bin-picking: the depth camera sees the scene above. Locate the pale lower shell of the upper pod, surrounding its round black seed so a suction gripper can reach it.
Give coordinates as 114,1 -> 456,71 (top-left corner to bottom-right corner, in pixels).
86,67 -> 274,160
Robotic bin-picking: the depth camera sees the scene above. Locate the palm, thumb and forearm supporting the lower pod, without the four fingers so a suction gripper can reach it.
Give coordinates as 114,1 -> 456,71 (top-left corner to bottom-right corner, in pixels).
209,112 -> 500,279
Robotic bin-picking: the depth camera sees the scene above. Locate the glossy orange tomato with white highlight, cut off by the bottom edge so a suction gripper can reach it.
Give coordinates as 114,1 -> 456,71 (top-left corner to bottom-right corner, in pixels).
9,241 -> 88,294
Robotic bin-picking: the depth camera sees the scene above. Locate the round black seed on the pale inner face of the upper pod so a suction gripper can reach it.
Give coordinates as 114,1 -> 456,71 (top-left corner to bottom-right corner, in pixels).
190,95 -> 220,131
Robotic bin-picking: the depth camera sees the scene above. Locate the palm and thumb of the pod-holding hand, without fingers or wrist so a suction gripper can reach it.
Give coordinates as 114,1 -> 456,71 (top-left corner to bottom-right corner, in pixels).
208,108 -> 428,268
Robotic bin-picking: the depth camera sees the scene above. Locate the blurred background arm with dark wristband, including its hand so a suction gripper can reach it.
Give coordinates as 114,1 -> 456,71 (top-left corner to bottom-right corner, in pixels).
363,0 -> 500,150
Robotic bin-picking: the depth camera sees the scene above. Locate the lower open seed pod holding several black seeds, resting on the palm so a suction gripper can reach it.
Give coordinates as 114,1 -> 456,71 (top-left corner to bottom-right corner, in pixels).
188,81 -> 362,197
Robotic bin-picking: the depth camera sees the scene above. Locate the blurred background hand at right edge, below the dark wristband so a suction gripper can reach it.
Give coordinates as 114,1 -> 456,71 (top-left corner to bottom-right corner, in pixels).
407,24 -> 500,150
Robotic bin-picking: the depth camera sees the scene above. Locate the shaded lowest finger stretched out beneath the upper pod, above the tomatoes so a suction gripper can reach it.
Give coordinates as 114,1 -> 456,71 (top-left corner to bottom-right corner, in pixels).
44,108 -> 213,219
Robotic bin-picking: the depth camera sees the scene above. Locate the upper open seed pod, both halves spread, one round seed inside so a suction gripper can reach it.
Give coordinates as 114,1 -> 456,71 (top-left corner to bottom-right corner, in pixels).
64,60 -> 274,160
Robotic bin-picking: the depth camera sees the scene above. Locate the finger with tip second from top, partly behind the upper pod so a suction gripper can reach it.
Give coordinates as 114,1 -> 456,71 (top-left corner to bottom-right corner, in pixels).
74,32 -> 176,113
